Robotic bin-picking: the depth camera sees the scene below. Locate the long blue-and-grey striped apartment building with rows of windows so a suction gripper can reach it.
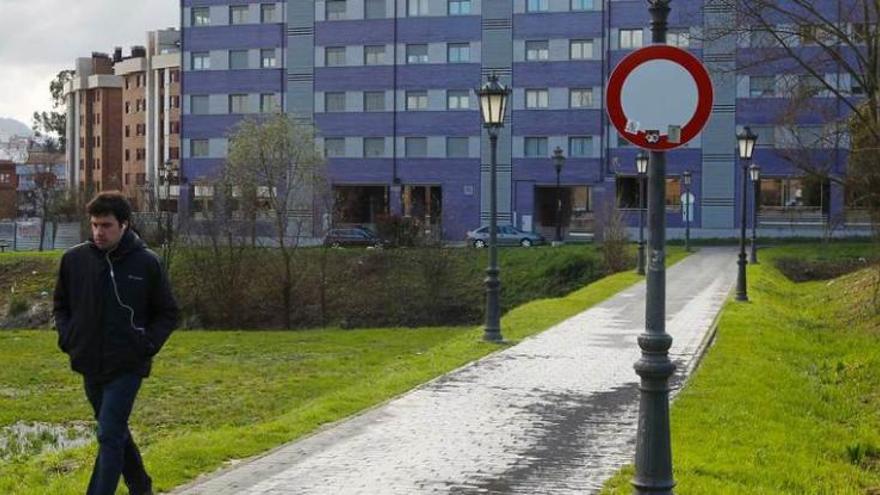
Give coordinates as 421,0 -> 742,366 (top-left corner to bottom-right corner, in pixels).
181,0 -> 867,241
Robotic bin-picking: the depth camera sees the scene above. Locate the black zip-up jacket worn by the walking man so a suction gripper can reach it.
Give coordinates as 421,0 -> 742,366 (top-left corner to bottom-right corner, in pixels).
54,229 -> 178,380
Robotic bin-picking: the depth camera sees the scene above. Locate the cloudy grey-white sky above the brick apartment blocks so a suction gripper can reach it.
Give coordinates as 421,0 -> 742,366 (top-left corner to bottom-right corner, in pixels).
0,0 -> 180,127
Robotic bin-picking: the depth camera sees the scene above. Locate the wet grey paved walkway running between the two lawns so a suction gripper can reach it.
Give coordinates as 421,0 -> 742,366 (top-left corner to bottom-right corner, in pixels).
178,248 -> 736,495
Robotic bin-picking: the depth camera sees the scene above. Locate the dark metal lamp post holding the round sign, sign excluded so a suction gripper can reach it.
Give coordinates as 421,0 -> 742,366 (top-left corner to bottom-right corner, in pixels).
631,0 -> 675,495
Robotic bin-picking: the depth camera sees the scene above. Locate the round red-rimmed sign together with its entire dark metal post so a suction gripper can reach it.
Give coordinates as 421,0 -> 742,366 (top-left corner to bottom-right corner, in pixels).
606,0 -> 713,494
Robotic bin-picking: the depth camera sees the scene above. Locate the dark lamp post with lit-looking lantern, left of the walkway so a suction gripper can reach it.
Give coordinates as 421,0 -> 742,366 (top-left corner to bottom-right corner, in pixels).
477,74 -> 510,342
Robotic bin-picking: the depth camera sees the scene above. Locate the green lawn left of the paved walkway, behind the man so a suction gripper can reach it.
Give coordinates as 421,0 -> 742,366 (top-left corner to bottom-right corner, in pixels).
0,249 -> 684,495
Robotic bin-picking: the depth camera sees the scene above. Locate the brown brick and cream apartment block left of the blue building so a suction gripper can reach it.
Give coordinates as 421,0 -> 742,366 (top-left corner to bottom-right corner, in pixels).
67,29 -> 180,209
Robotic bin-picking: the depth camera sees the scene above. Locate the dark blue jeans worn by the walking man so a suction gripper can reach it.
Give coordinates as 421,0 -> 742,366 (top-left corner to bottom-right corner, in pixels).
84,373 -> 152,495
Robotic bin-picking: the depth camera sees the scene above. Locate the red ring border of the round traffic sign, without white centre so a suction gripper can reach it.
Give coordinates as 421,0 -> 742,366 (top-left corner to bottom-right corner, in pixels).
606,45 -> 714,151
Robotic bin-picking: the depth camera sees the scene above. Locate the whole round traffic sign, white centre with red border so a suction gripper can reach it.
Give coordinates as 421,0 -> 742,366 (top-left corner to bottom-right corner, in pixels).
606,45 -> 713,151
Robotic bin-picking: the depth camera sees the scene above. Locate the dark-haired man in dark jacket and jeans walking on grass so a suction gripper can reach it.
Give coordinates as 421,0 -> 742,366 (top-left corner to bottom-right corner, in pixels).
54,192 -> 178,495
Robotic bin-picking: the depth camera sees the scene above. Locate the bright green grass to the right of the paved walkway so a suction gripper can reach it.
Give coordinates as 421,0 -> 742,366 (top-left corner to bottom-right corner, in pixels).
603,244 -> 880,495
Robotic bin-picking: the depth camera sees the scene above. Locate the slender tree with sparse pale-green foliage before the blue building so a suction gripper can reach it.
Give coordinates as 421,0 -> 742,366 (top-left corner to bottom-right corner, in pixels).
224,114 -> 324,328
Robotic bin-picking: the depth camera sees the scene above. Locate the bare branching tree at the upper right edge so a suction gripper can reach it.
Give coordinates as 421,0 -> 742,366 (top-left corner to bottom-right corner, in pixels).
704,0 -> 880,229
